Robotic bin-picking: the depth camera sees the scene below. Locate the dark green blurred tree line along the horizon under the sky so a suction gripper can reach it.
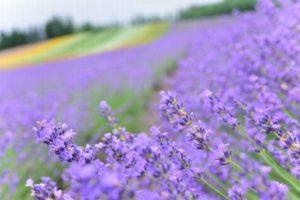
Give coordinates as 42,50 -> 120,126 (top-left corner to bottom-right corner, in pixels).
0,0 -> 256,49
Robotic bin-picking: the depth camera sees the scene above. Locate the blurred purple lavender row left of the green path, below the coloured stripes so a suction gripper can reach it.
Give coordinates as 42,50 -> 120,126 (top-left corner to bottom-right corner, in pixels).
0,25 -> 206,199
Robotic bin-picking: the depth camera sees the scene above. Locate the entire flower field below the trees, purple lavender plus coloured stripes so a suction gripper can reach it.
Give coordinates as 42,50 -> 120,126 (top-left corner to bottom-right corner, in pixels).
0,0 -> 300,200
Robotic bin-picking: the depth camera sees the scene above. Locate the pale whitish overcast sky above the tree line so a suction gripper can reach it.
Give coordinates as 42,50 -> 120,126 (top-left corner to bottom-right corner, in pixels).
0,0 -> 221,31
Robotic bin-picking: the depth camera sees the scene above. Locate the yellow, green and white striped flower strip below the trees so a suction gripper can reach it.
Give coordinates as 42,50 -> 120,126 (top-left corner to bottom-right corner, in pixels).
0,22 -> 169,69
